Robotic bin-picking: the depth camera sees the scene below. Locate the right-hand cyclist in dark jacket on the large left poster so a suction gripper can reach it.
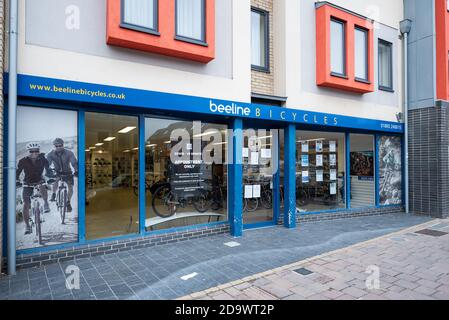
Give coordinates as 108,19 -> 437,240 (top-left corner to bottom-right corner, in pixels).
47,138 -> 78,212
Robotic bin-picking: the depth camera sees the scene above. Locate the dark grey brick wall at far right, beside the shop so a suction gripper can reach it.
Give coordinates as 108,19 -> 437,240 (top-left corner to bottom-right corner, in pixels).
409,101 -> 449,218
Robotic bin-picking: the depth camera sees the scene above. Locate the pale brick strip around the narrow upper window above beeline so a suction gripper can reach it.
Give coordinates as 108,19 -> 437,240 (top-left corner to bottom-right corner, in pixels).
251,0 -> 274,95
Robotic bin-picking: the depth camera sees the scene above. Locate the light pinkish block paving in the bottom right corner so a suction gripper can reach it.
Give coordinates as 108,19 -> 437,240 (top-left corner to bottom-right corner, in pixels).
179,219 -> 449,300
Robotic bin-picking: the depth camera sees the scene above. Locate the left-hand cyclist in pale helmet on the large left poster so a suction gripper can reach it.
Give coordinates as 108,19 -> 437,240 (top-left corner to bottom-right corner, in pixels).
16,142 -> 50,234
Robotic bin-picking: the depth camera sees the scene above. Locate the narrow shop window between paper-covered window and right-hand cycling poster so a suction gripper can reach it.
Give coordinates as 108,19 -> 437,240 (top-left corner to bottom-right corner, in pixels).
350,134 -> 376,208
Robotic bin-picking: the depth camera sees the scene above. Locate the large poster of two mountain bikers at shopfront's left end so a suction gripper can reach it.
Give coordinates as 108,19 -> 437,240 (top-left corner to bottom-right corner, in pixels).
16,106 -> 78,249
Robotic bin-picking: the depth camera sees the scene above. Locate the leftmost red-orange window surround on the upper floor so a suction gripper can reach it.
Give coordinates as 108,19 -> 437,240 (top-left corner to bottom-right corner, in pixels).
106,0 -> 215,63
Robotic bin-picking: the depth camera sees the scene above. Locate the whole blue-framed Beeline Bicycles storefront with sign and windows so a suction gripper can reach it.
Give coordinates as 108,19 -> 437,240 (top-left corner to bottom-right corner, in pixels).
6,75 -> 402,254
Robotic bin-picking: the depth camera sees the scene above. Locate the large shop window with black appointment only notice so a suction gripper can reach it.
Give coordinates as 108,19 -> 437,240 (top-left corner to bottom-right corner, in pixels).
145,118 -> 228,231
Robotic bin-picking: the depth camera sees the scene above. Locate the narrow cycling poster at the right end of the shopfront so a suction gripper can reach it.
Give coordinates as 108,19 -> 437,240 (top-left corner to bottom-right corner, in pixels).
379,136 -> 402,205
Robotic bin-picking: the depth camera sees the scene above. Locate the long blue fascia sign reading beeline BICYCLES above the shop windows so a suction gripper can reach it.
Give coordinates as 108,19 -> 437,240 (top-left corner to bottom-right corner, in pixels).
5,74 -> 404,133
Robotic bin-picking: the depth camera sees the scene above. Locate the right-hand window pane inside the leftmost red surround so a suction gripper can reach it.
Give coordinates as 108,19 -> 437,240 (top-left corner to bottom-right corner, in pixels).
176,0 -> 206,43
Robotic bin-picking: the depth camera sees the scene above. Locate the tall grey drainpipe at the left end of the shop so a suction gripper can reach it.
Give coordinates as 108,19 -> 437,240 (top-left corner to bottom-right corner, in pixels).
7,0 -> 19,275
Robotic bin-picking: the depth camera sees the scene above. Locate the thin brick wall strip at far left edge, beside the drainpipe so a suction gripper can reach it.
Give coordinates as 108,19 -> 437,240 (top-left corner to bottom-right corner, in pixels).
0,0 -> 5,276
